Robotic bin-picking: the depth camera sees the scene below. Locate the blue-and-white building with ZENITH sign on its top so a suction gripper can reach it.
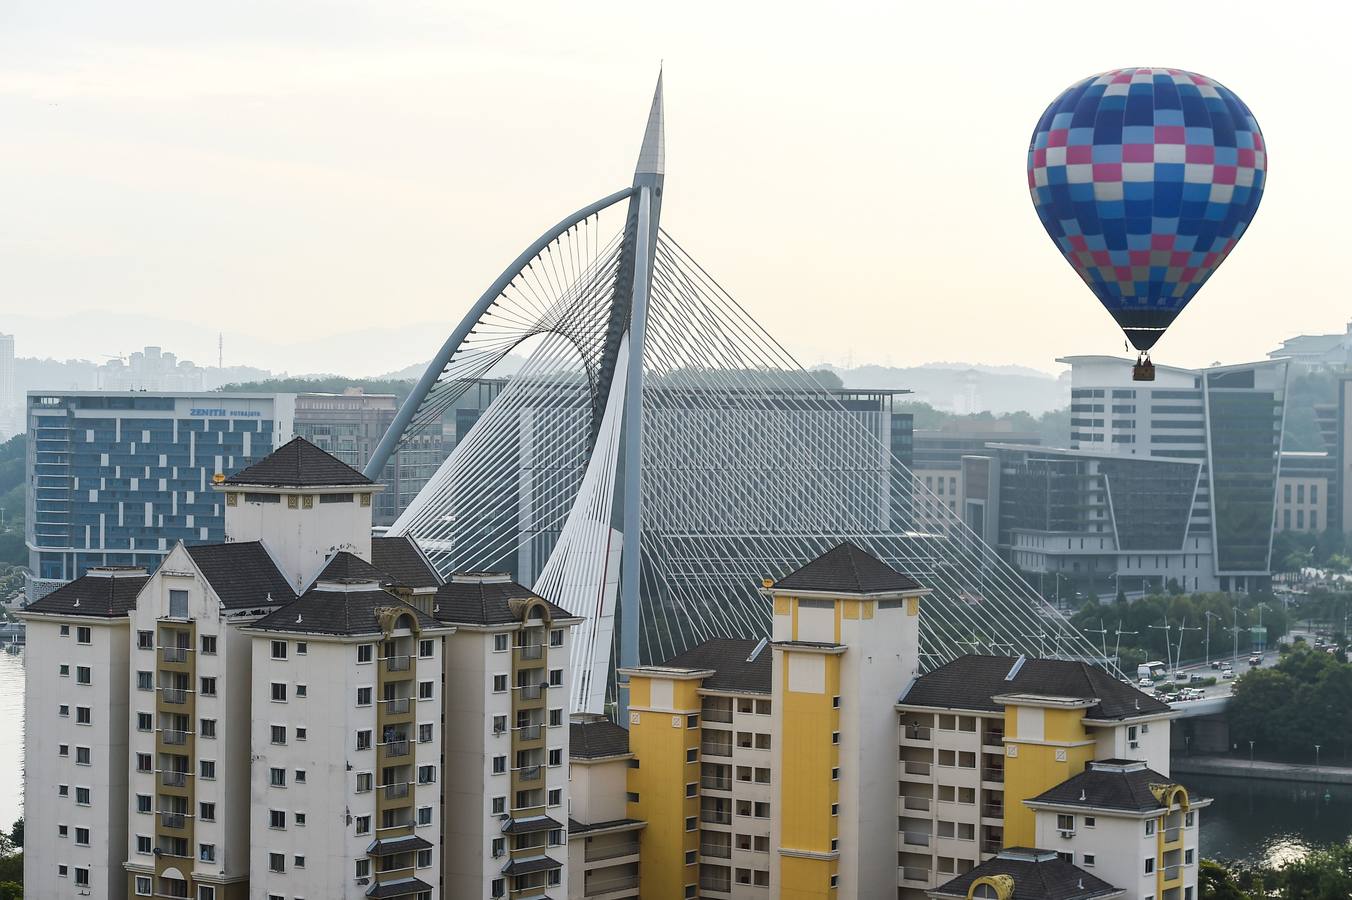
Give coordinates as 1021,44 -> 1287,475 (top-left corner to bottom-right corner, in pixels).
24,392 -> 293,601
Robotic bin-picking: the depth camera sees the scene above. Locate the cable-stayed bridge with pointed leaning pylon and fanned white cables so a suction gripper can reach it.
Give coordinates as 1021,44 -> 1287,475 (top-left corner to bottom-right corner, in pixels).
366,77 -> 1101,711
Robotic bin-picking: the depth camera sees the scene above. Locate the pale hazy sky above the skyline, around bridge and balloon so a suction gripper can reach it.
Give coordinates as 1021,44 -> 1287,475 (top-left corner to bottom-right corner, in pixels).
0,0 -> 1352,374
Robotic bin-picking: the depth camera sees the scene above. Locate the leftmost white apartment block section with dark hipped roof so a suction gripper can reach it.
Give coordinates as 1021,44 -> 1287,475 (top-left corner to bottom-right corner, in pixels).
23,569 -> 147,900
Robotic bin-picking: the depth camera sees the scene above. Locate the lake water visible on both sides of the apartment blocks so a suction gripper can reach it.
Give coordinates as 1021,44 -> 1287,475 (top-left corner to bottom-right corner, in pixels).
0,653 -> 1352,862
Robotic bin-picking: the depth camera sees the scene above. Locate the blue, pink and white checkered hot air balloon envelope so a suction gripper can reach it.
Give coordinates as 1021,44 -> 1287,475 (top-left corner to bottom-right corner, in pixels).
1028,69 -> 1267,350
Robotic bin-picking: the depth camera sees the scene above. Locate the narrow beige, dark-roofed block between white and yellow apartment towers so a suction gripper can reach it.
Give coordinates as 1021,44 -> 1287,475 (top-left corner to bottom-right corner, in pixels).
568,712 -> 645,900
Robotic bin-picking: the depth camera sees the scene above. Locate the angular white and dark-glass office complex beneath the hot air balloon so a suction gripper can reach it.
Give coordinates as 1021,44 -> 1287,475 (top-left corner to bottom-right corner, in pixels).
964,357 -> 1286,599
